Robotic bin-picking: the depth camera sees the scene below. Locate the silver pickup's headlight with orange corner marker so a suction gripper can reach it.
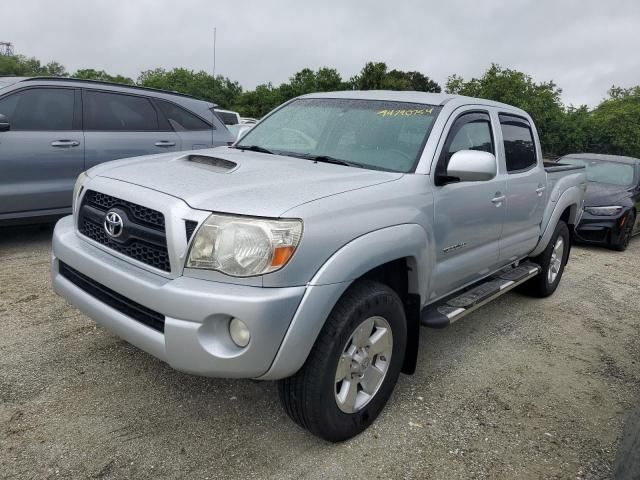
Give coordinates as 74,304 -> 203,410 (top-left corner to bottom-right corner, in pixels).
187,213 -> 302,277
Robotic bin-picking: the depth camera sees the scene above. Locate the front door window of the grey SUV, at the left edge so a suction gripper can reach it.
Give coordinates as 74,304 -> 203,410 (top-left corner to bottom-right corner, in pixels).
0,88 -> 75,131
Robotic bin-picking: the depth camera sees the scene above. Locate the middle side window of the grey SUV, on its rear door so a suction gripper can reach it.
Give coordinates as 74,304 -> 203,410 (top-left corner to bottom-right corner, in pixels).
84,90 -> 159,132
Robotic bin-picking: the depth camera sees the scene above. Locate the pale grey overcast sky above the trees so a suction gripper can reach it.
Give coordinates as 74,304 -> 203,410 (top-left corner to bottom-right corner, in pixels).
0,0 -> 640,106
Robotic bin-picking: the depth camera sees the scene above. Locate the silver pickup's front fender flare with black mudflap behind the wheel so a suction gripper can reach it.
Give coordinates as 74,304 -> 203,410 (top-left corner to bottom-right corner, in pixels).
260,224 -> 434,380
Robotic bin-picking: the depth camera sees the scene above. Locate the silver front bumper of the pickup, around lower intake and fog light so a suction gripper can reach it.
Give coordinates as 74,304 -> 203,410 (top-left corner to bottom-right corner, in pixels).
51,217 -> 306,378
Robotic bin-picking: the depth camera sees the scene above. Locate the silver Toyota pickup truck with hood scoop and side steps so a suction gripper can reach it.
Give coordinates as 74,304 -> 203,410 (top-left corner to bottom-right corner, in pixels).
52,91 -> 586,441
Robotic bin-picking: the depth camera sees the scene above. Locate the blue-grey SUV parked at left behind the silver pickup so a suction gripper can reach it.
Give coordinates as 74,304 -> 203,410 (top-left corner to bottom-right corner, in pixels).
0,77 -> 234,223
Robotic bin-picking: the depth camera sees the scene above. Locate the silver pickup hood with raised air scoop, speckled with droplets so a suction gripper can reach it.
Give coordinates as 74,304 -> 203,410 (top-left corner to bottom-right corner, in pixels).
88,147 -> 403,217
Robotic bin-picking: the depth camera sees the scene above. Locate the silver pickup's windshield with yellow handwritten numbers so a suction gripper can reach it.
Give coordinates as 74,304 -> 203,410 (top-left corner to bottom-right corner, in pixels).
236,98 -> 440,173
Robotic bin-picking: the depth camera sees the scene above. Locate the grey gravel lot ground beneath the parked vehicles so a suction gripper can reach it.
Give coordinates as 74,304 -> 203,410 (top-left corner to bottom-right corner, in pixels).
0,228 -> 640,479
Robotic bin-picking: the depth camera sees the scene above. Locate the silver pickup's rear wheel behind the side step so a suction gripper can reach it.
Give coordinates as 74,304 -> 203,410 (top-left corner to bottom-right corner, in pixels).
521,220 -> 571,298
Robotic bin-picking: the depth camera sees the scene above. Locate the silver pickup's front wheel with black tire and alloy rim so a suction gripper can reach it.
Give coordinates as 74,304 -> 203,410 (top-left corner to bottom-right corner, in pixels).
278,280 -> 407,442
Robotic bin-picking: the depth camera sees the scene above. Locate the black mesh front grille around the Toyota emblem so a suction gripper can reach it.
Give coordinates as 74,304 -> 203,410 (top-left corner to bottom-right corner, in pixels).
78,190 -> 171,272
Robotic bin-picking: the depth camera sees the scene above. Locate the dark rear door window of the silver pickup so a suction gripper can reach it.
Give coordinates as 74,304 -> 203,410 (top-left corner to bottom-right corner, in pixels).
500,114 -> 538,173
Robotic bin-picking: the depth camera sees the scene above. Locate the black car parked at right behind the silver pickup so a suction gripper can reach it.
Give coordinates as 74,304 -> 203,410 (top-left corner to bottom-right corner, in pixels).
559,153 -> 640,251
